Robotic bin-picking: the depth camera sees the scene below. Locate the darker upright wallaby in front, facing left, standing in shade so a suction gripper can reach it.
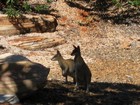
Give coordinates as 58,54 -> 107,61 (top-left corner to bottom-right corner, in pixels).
71,46 -> 92,92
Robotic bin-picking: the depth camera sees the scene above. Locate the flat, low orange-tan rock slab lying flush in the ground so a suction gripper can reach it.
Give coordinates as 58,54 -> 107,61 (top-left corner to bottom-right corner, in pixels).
8,35 -> 66,50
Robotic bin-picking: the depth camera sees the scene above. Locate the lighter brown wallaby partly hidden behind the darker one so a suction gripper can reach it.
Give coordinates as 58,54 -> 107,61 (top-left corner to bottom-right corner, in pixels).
51,50 -> 75,83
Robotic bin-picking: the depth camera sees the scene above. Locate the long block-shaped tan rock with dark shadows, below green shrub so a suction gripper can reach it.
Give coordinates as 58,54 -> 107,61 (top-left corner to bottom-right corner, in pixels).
0,14 -> 57,35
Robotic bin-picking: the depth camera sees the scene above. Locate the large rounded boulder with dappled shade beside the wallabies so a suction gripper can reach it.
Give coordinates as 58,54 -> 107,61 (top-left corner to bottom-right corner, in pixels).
0,55 -> 50,97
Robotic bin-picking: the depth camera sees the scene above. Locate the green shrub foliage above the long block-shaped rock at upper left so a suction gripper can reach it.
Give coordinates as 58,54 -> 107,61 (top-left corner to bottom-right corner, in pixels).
0,0 -> 52,17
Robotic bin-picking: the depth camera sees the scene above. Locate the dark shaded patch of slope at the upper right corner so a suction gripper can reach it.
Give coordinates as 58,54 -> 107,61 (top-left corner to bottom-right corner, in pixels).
66,0 -> 140,25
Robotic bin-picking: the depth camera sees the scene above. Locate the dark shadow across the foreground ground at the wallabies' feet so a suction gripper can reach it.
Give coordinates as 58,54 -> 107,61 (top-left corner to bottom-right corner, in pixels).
21,81 -> 140,105
